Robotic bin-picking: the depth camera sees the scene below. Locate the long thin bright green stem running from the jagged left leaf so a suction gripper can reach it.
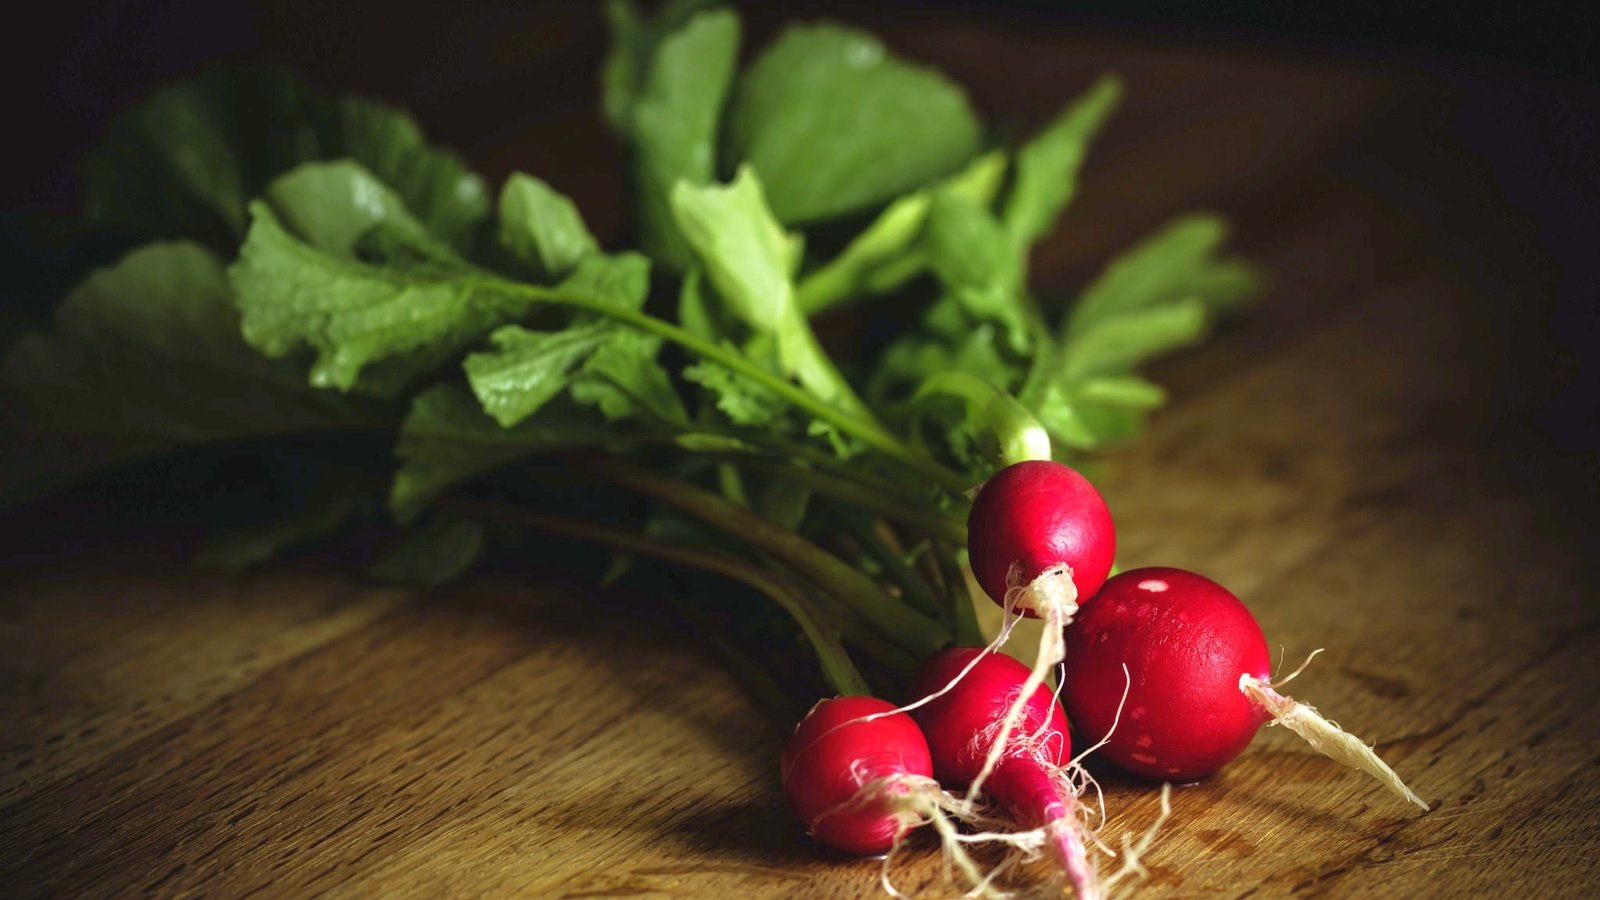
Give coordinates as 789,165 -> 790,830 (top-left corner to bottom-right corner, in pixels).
485,280 -> 971,493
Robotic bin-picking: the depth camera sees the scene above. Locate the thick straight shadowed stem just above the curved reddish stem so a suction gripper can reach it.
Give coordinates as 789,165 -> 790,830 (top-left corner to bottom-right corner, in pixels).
578,460 -> 950,658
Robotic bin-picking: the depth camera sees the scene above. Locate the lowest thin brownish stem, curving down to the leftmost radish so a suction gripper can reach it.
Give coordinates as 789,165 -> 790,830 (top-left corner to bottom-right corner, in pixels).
448,500 -> 872,695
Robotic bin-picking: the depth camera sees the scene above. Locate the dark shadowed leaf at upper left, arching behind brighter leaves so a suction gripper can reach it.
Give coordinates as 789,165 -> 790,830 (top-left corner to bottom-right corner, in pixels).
83,67 -> 488,251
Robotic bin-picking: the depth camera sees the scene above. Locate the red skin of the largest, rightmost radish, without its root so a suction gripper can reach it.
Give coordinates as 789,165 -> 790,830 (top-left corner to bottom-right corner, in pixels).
1061,567 -> 1272,781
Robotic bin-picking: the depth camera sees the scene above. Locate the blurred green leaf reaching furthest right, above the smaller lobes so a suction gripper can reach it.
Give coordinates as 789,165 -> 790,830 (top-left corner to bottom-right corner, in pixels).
1062,213 -> 1264,340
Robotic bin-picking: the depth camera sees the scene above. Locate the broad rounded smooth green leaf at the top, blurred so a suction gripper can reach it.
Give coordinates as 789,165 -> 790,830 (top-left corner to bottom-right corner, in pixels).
728,24 -> 982,224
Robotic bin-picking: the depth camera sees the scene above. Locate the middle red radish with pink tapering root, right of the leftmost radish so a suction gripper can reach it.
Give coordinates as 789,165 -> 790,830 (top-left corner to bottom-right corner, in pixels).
912,647 -> 1098,898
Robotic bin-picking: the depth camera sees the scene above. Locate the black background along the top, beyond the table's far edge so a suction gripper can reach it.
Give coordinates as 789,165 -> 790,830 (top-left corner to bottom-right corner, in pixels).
12,0 -> 1600,211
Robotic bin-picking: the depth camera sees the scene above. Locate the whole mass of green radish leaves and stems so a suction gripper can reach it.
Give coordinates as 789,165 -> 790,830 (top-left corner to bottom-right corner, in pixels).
0,0 -> 1264,689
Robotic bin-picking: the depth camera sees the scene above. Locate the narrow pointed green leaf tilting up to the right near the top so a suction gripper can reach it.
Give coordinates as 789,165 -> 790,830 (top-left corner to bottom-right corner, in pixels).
1005,75 -> 1122,247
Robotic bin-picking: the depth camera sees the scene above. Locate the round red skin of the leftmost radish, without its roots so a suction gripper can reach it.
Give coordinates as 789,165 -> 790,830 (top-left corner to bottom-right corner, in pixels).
782,697 -> 933,857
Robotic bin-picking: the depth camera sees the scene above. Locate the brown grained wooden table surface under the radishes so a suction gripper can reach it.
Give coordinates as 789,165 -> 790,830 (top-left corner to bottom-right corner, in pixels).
0,5 -> 1600,897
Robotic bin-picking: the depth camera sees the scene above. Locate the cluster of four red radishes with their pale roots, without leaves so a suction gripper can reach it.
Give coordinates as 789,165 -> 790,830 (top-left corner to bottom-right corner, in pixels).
784,461 -> 1427,897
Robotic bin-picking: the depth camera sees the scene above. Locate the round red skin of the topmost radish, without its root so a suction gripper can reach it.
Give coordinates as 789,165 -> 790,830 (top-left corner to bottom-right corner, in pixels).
966,460 -> 1117,615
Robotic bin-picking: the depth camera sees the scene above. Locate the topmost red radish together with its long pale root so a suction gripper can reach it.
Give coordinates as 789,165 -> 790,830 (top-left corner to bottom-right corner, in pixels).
966,460 -> 1117,813
